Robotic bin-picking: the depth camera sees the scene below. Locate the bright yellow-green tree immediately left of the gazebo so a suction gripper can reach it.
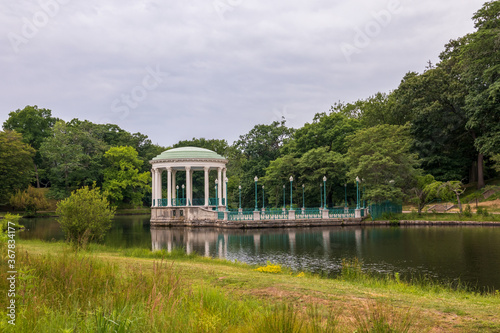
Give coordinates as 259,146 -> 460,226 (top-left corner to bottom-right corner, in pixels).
103,147 -> 151,206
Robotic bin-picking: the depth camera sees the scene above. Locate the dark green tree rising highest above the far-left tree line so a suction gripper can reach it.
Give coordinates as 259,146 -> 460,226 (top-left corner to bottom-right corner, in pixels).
3,105 -> 57,188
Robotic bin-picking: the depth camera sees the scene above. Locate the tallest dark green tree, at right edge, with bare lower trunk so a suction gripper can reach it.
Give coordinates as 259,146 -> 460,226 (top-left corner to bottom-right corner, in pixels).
440,1 -> 500,188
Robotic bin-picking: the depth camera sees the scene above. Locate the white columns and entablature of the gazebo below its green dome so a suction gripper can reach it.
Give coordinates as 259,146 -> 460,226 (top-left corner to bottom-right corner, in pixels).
150,155 -> 228,207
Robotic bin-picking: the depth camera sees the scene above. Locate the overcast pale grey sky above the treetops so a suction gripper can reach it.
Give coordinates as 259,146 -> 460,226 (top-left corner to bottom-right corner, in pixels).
0,0 -> 484,147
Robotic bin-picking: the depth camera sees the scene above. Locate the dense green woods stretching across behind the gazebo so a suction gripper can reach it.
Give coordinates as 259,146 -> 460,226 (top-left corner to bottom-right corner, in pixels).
0,1 -> 500,210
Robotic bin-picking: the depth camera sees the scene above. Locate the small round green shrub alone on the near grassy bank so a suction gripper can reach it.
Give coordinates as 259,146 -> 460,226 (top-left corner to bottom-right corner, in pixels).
56,186 -> 115,250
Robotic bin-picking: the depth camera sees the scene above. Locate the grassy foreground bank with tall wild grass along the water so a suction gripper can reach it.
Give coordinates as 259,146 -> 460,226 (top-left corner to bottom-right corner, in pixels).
0,241 -> 500,332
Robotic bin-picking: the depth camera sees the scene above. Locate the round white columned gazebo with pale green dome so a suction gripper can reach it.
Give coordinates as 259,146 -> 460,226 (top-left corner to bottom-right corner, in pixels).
150,147 -> 228,210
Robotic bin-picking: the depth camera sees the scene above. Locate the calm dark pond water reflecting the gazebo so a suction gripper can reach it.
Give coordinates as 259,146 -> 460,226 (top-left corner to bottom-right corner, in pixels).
19,216 -> 500,289
